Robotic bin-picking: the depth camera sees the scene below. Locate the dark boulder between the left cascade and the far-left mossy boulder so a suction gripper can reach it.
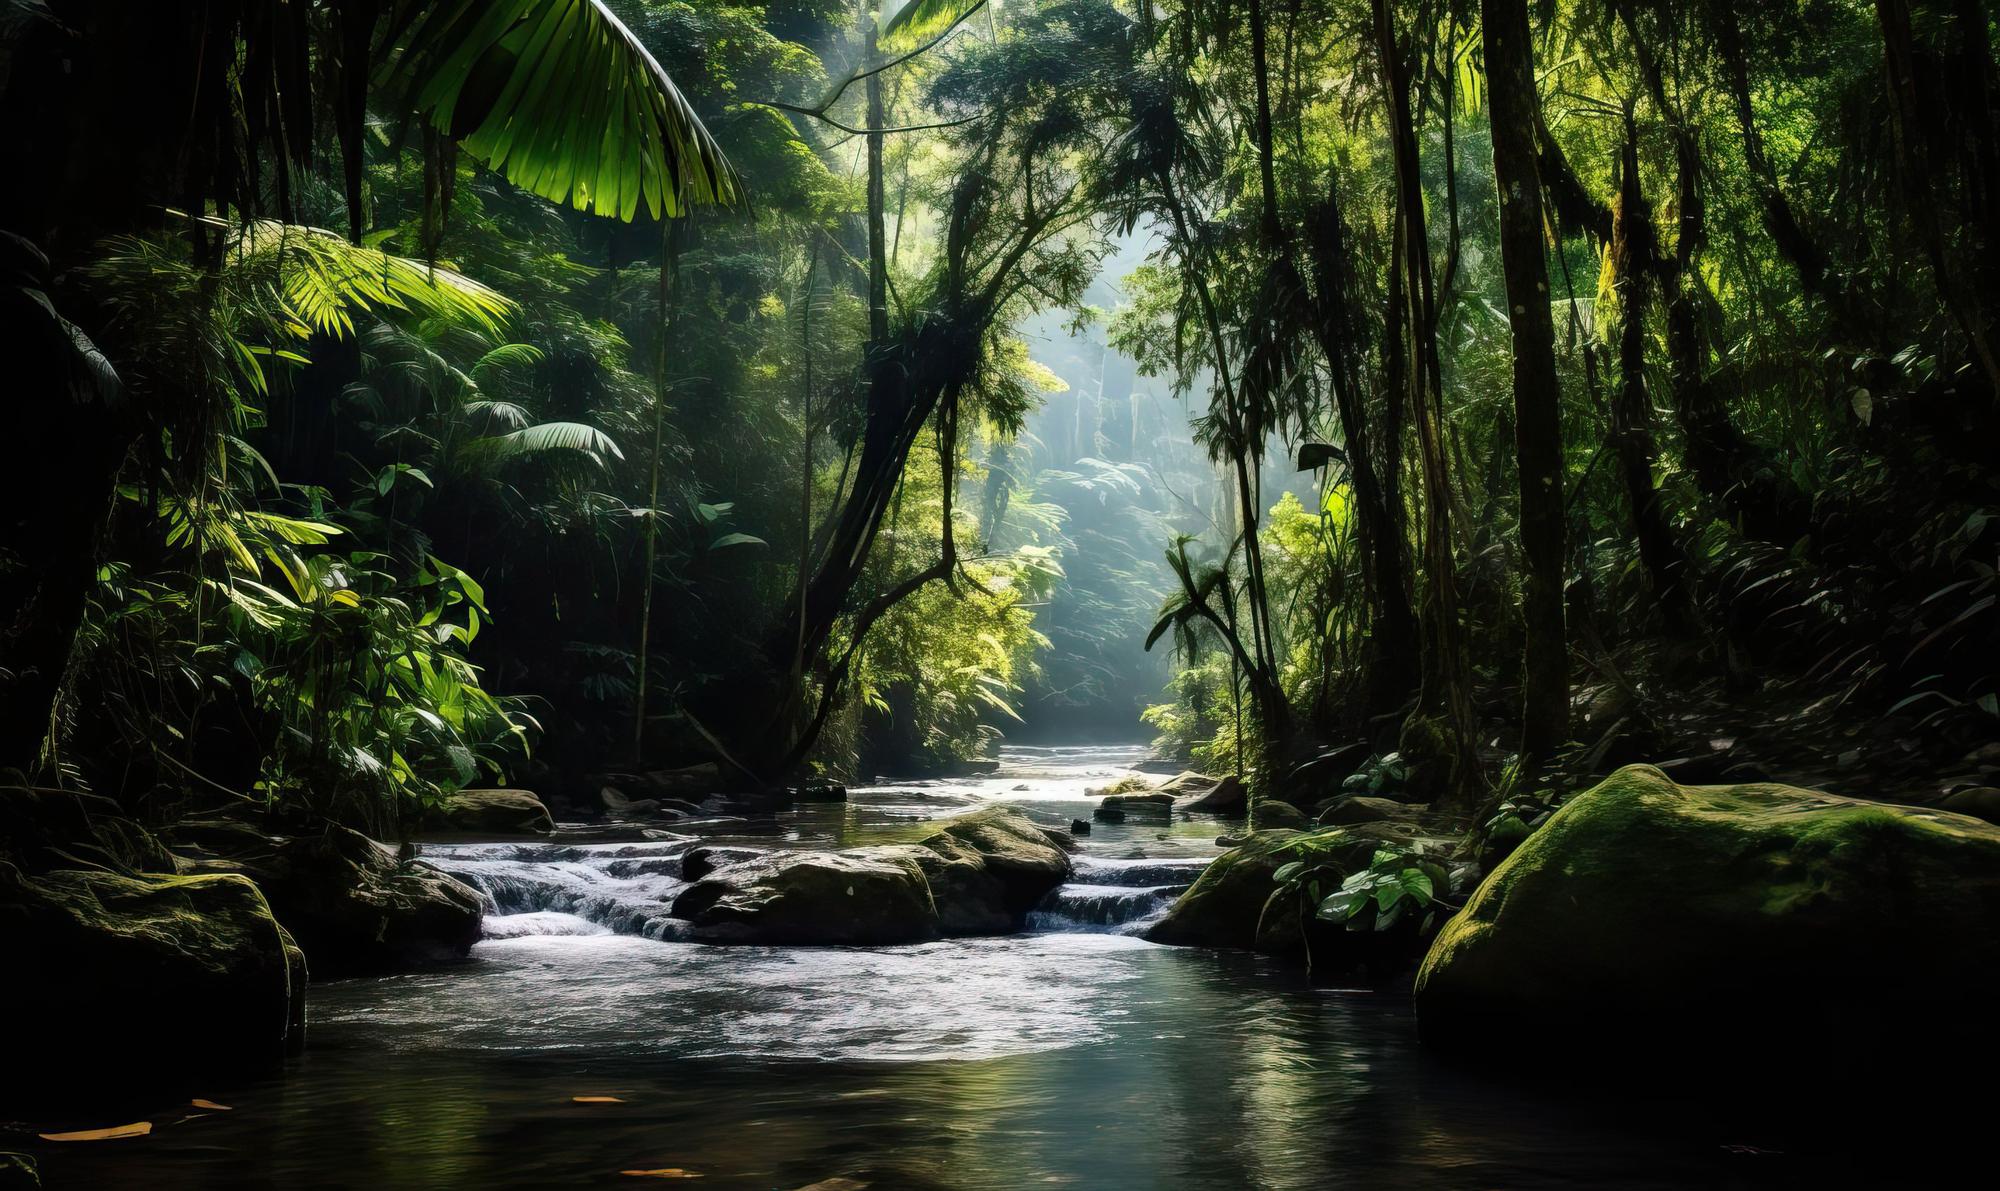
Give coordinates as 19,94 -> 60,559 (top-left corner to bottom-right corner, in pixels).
176,819 -> 484,979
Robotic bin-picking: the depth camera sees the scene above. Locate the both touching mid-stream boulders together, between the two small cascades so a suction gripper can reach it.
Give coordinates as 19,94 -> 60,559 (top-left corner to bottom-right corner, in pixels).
674,805 -> 1070,945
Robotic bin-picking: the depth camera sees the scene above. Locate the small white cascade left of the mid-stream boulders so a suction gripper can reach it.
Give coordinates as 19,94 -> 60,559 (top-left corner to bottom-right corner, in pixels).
422,839 -> 690,939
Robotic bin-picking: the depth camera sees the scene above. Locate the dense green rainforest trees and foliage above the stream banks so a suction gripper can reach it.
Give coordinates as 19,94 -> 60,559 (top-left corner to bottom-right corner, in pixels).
0,0 -> 2000,827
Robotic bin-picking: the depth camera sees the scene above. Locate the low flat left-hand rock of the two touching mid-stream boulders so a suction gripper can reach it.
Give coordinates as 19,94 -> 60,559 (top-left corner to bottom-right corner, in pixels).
674,849 -> 938,945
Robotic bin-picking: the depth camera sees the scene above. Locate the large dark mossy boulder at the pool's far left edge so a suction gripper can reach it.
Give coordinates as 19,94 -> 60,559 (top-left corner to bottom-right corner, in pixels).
0,861 -> 306,1109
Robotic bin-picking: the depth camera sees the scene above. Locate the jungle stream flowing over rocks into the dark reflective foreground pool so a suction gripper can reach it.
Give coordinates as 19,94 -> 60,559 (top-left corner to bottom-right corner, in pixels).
40,747 -> 1840,1191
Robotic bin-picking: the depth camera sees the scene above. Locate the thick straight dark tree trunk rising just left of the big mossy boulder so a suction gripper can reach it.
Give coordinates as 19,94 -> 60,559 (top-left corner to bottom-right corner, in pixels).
1480,0 -> 1570,759
